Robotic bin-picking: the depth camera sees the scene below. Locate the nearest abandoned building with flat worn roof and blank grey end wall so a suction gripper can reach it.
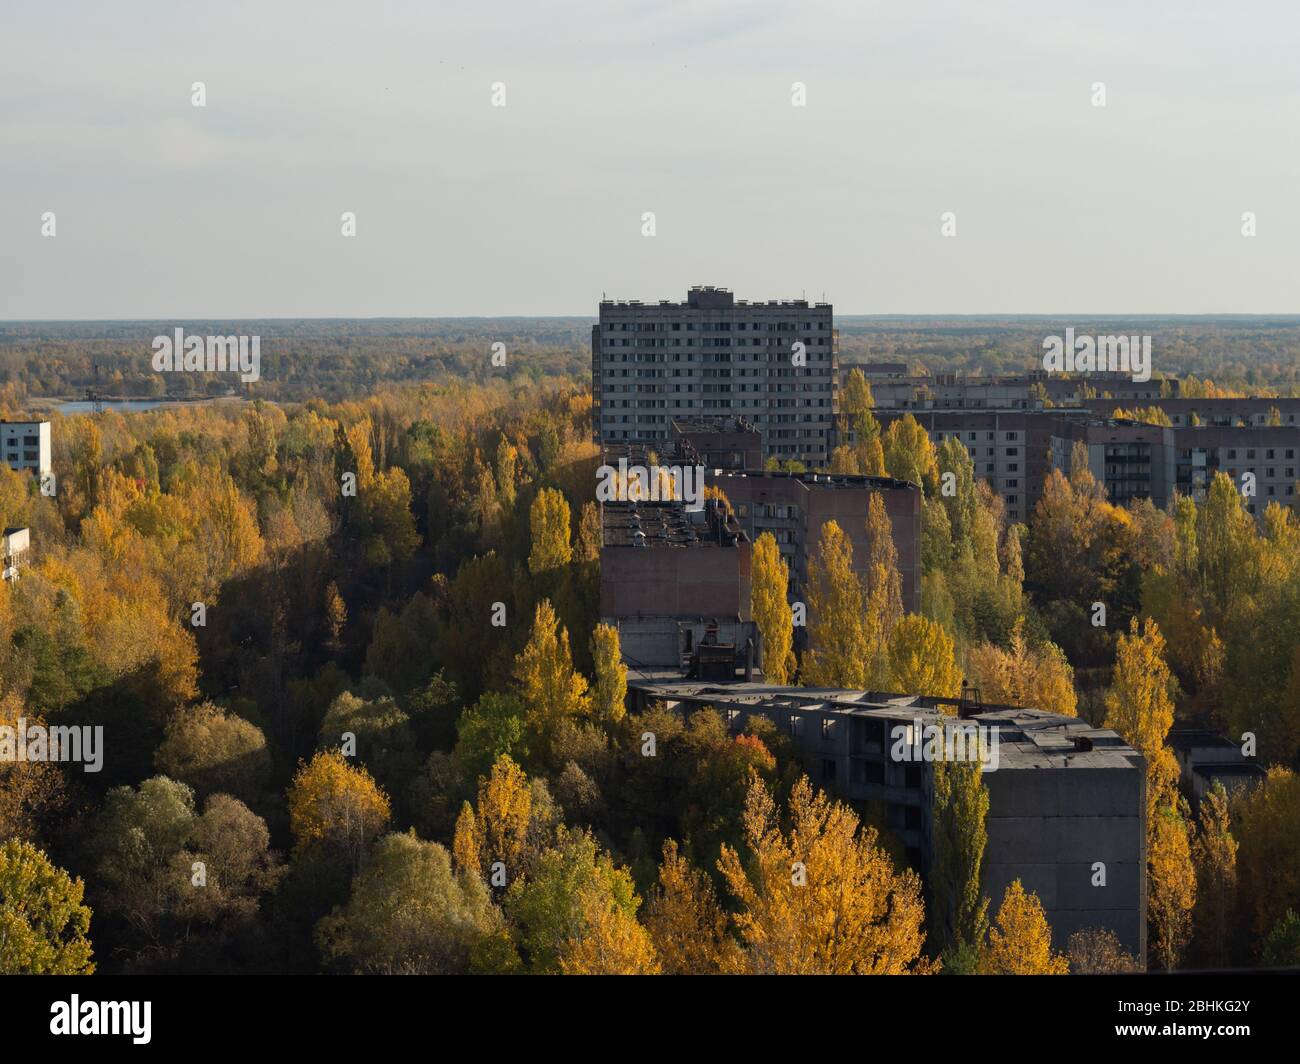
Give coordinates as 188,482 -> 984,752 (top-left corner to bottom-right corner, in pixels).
628,675 -> 1147,959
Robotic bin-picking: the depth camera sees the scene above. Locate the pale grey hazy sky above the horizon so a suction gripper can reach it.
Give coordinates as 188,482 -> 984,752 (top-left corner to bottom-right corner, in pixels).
0,0 -> 1300,319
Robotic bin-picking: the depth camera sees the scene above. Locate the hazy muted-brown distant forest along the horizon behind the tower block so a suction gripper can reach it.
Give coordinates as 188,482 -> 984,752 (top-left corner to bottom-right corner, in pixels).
0,316 -> 1300,408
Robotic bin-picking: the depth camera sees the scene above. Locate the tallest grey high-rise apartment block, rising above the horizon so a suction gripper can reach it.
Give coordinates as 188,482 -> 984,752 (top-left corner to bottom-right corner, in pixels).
592,287 -> 839,466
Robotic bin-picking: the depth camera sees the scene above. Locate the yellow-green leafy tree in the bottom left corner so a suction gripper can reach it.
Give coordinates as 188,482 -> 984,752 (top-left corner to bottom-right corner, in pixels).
0,839 -> 95,976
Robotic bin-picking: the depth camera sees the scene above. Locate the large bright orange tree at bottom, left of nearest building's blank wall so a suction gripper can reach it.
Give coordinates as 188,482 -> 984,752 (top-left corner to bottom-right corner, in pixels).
718,777 -> 930,974
